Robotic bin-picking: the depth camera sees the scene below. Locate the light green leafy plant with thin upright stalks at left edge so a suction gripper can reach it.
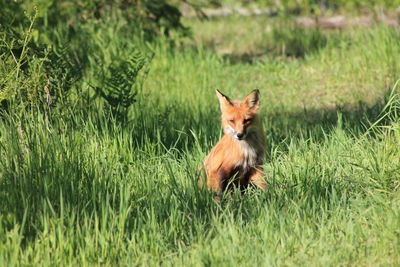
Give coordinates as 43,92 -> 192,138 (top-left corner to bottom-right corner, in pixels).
0,12 -> 81,114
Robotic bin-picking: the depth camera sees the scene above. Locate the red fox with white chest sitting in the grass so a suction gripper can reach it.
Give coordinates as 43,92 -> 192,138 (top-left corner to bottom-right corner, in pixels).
199,90 -> 265,196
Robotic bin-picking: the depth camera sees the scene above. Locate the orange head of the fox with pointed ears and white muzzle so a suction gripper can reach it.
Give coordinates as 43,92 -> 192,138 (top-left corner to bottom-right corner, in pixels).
215,89 -> 260,140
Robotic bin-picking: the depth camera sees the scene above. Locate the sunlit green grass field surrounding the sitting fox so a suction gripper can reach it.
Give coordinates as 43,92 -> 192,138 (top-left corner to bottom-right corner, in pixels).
0,11 -> 400,266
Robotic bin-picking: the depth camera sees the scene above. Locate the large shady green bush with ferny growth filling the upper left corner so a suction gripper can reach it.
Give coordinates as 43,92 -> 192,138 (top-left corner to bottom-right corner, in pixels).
0,0 -> 180,116
